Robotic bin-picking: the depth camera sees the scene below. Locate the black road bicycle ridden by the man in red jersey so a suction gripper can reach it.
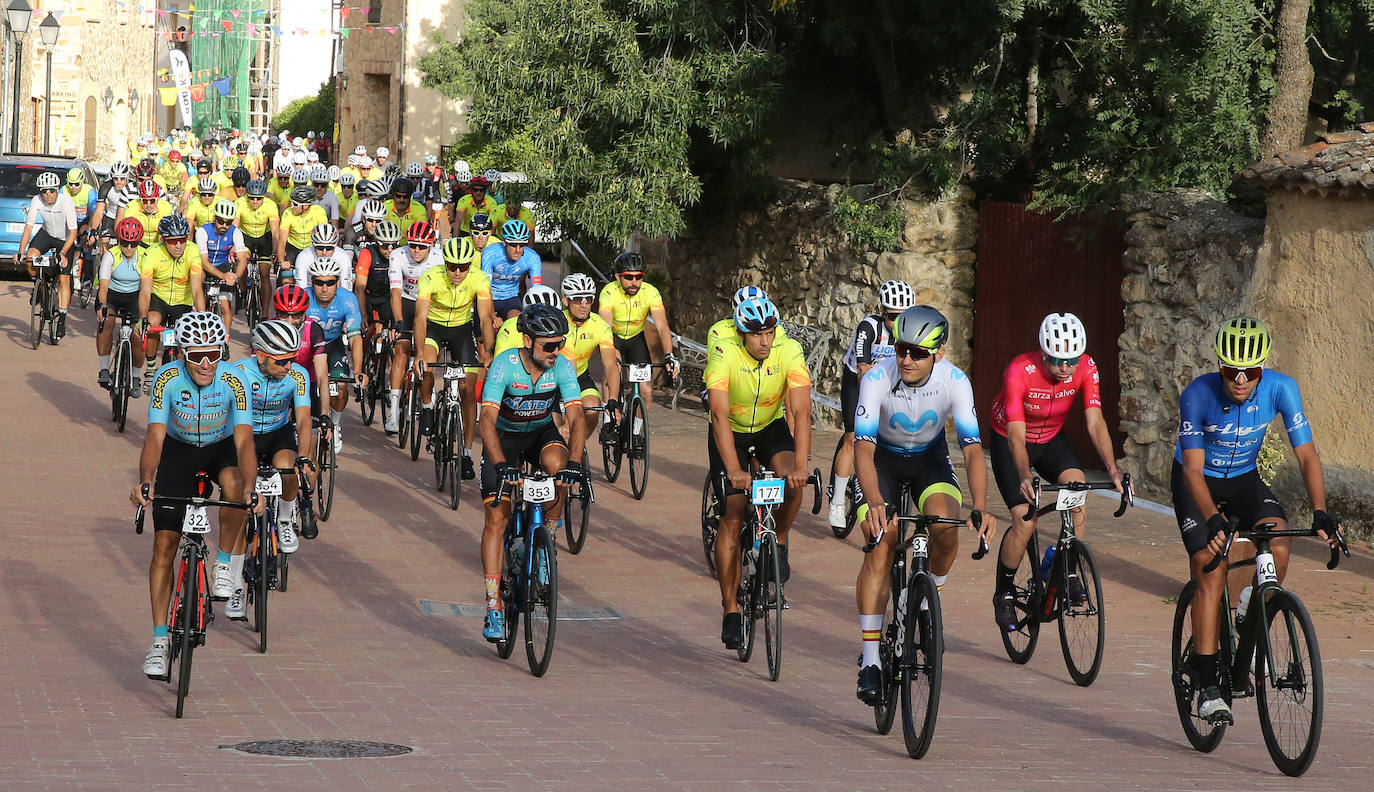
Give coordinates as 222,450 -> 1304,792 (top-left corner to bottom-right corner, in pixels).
999,473 -> 1134,688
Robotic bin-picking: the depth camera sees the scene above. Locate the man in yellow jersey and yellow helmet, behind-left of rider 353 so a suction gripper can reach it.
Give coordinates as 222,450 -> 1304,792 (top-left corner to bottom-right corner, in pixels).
409,238 -> 492,467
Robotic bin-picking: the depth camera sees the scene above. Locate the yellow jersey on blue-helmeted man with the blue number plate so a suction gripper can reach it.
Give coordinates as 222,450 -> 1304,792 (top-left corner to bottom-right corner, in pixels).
702,338 -> 811,433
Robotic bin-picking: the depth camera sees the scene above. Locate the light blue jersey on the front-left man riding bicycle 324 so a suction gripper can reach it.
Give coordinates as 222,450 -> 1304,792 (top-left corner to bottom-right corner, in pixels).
148,360 -> 251,447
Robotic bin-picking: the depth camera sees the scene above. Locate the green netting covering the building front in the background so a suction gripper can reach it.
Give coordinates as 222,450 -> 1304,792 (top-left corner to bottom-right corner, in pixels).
191,0 -> 268,135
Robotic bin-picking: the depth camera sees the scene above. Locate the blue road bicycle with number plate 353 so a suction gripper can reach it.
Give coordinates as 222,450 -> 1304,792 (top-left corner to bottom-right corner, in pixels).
496,468 -> 558,677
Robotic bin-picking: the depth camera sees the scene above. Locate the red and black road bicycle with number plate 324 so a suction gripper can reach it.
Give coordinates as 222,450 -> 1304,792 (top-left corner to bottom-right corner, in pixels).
133,470 -> 250,718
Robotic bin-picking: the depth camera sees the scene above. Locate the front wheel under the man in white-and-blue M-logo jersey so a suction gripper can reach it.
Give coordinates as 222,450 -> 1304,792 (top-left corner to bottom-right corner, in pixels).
893,572 -> 944,759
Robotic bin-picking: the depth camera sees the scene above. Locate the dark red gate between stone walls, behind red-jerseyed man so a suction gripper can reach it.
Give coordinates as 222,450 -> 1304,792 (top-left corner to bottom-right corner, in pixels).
971,201 -> 1125,469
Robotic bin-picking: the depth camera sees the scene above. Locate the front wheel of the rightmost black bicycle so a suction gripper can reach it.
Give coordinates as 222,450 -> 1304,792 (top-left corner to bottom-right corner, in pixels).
1250,591 -> 1325,776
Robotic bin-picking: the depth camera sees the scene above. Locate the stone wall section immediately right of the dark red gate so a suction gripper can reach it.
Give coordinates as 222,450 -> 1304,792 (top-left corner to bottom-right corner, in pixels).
1120,191 -> 1264,499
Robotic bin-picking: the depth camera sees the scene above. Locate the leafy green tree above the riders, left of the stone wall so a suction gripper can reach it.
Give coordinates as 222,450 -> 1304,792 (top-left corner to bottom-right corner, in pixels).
419,0 -> 783,242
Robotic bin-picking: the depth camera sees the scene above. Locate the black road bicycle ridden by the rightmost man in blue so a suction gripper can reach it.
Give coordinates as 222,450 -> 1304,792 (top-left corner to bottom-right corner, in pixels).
1169,503 -> 1351,776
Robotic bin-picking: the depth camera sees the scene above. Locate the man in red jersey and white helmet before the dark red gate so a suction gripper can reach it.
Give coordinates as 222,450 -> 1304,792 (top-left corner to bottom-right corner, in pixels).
991,314 -> 1121,630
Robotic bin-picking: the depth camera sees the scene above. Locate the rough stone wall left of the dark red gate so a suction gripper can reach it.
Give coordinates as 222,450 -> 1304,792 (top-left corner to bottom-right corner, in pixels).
642,180 -> 978,397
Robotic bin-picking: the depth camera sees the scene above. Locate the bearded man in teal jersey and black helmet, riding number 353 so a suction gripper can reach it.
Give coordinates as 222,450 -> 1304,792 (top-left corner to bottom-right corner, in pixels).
478,305 -> 587,641
